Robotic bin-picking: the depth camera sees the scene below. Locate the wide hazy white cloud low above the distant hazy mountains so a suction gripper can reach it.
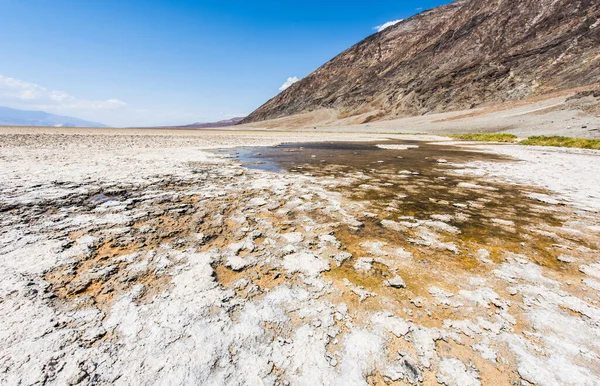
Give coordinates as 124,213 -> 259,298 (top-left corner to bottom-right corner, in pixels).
0,75 -> 126,113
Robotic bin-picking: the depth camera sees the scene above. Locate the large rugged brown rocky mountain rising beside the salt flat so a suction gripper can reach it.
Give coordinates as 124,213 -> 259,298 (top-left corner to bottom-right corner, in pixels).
242,0 -> 600,123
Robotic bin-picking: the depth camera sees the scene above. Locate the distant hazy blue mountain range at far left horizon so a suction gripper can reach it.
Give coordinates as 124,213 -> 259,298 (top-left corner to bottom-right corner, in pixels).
0,106 -> 108,127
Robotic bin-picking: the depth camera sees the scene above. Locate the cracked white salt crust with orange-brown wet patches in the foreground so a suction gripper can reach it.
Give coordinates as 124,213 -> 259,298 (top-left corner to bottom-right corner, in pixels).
0,132 -> 600,386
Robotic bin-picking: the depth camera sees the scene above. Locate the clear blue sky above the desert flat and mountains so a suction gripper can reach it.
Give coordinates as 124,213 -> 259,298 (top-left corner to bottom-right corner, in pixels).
0,0 -> 448,126
